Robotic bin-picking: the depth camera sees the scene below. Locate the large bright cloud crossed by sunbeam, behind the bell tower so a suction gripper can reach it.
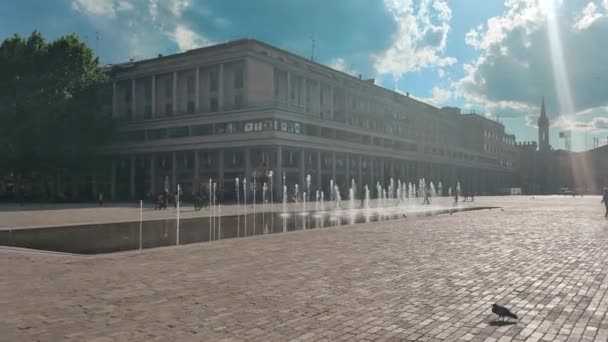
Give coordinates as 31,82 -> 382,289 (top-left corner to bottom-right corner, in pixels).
451,0 -> 608,126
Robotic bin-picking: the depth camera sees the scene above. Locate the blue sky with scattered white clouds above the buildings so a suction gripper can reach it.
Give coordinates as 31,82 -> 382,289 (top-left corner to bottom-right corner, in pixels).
0,0 -> 608,150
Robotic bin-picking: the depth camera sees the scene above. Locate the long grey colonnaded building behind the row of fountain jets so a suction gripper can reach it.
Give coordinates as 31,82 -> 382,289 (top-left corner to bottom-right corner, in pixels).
100,39 -> 517,200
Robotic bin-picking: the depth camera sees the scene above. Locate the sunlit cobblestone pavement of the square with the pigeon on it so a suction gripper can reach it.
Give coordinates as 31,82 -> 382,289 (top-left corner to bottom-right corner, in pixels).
0,197 -> 608,342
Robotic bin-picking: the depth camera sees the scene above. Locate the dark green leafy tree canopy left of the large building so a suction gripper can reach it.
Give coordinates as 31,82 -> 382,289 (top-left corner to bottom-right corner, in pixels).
0,31 -> 113,173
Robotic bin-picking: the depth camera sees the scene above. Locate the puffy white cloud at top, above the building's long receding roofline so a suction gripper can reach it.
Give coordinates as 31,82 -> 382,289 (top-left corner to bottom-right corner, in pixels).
373,0 -> 456,79
